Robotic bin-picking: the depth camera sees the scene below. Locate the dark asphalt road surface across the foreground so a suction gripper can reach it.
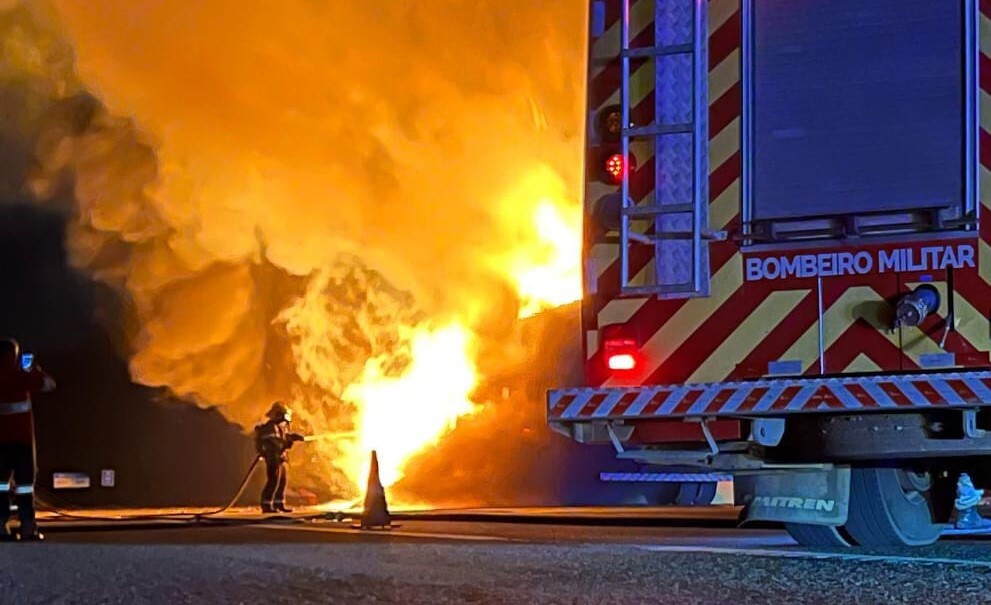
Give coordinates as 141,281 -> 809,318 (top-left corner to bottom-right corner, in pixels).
0,509 -> 991,605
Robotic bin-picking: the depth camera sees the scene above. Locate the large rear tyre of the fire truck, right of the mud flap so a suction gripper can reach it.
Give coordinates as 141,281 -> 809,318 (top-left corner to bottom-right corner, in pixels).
846,468 -> 943,547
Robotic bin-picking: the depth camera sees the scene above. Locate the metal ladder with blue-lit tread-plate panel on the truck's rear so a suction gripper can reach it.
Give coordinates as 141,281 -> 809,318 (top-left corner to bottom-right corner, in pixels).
620,0 -> 725,298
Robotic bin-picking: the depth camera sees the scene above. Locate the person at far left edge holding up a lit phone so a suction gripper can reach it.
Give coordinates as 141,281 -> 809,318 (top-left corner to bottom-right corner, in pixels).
0,339 -> 55,541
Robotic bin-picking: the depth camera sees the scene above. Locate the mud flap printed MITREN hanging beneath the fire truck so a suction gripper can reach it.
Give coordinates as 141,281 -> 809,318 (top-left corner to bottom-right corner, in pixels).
737,467 -> 850,526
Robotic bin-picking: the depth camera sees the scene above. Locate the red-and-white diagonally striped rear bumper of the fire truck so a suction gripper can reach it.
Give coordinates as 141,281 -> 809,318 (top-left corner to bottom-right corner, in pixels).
547,371 -> 991,424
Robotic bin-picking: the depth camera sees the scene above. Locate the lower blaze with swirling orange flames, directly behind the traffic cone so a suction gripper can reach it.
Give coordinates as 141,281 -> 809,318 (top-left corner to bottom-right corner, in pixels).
278,258 -> 478,494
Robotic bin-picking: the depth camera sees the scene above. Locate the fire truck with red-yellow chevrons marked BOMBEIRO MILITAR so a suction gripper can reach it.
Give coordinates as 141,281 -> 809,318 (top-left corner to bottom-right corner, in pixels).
547,0 -> 991,547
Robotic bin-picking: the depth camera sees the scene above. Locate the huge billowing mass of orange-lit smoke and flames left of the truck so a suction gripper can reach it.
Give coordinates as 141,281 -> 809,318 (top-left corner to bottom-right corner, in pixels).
11,0 -> 585,495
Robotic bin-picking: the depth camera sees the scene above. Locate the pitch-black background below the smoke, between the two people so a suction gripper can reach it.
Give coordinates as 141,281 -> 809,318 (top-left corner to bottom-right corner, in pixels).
0,201 -> 260,505
